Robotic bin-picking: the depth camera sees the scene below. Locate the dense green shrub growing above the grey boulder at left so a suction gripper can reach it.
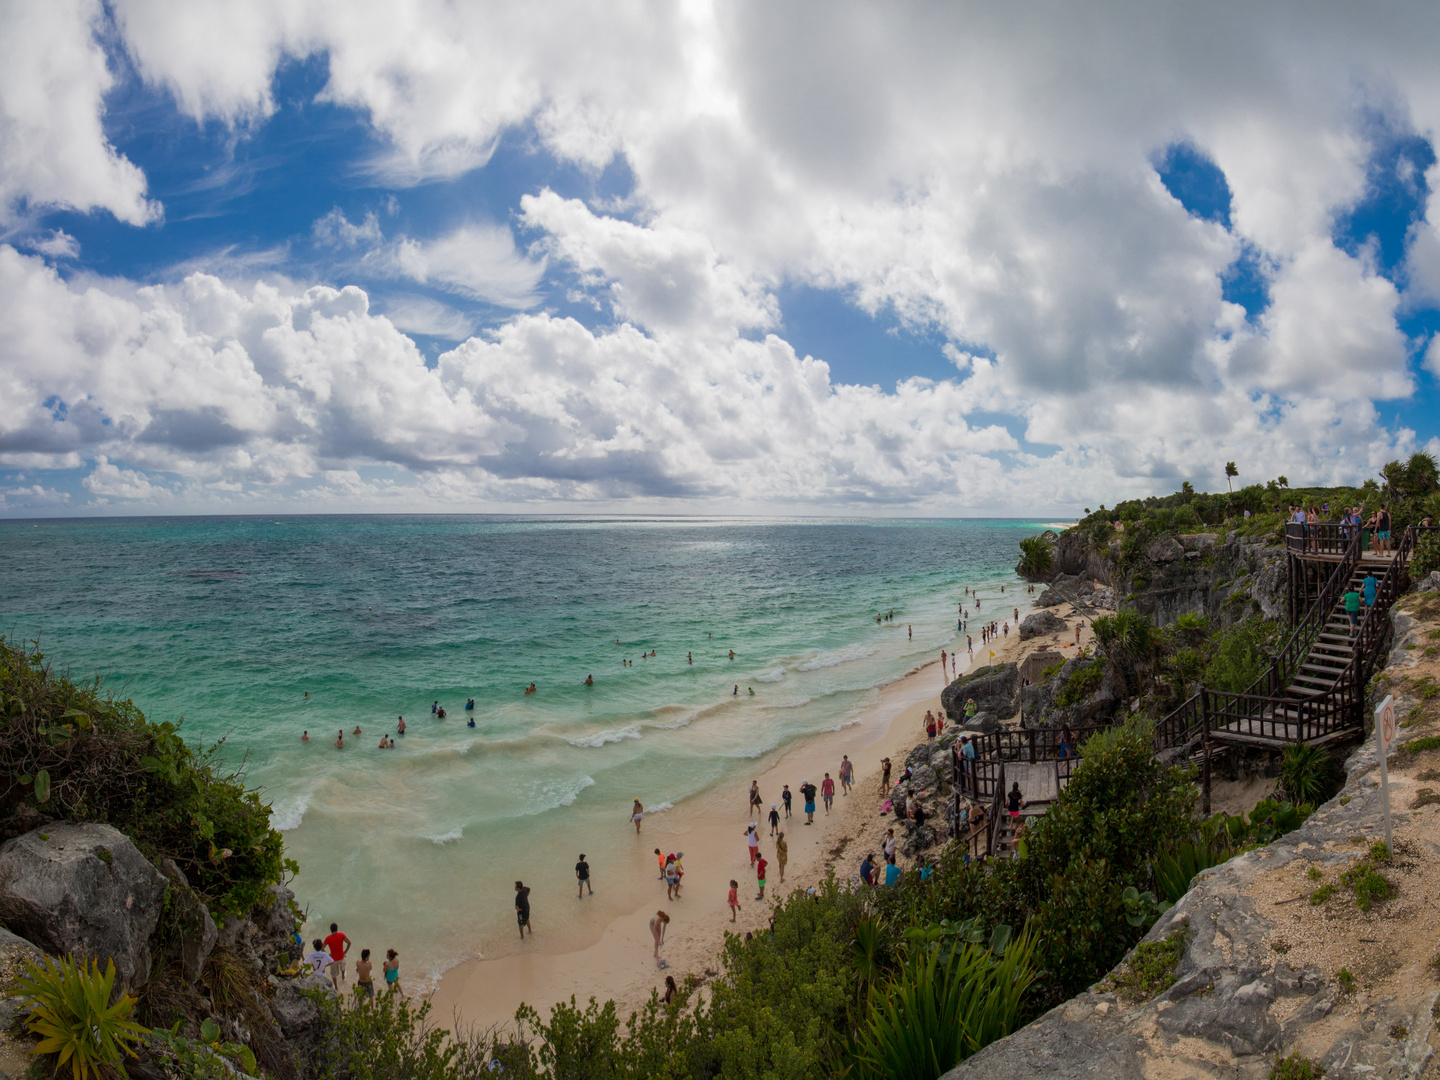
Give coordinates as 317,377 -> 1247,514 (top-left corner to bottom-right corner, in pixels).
0,636 -> 298,919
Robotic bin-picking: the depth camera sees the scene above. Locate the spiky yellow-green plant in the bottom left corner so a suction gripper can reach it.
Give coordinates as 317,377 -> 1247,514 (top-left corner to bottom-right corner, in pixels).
17,956 -> 150,1080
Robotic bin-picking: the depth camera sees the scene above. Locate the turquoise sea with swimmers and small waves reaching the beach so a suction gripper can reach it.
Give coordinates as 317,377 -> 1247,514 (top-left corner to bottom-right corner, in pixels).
0,517 -> 1037,976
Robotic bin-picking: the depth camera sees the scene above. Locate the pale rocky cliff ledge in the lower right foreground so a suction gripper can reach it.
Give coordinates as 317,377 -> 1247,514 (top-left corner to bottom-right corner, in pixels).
945,593 -> 1440,1080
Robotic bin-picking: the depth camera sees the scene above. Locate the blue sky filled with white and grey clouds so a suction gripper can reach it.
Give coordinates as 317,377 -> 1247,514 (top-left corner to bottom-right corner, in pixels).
0,0 -> 1440,517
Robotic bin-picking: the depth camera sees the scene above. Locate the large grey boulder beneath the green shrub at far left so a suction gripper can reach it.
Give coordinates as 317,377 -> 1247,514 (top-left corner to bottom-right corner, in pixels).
0,822 -> 166,989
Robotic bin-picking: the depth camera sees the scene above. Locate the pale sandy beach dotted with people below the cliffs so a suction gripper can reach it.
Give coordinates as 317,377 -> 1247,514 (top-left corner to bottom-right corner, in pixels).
431,596 -> 1092,1028
